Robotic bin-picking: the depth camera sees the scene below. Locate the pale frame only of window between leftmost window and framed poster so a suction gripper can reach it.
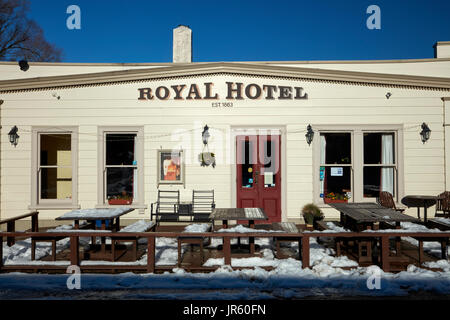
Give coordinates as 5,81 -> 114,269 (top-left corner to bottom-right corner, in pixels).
95,126 -> 147,209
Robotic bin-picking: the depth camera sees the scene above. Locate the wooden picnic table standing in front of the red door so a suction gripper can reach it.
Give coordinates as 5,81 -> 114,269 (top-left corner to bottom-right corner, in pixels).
209,208 -> 268,254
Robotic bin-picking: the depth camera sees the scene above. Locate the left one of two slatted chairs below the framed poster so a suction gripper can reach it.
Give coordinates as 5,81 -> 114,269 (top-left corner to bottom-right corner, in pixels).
150,190 -> 180,225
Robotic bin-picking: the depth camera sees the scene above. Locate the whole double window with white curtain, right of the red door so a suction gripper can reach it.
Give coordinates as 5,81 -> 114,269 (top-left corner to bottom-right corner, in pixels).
313,125 -> 403,203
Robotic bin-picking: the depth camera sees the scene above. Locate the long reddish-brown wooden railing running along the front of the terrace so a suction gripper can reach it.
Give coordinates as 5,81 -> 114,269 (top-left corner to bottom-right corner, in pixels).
0,231 -> 450,273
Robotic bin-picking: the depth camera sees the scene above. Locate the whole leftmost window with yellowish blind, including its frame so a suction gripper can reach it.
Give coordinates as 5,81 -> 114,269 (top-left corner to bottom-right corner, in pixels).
30,128 -> 78,209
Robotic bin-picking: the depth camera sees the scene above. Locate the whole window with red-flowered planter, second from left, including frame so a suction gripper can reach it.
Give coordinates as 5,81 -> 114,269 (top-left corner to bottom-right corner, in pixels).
97,127 -> 144,207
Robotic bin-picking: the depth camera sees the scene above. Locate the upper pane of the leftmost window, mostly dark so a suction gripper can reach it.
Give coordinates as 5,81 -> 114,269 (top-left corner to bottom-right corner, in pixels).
40,134 -> 72,166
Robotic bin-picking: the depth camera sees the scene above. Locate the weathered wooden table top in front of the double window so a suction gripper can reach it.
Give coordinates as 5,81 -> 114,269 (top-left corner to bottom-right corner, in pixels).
329,202 -> 418,223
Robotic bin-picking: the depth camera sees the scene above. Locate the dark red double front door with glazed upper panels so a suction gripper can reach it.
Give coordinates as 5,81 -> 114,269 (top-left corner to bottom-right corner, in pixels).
236,135 -> 281,223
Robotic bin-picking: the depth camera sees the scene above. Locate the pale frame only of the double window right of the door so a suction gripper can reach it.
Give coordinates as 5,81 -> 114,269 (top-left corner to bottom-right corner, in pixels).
312,124 -> 404,207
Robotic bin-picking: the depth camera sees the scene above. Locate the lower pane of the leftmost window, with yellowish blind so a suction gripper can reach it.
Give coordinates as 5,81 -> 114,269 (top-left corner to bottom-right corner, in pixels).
40,168 -> 72,200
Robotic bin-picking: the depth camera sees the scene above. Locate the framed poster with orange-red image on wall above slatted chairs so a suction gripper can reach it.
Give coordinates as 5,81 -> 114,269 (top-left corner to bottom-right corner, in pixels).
157,149 -> 184,185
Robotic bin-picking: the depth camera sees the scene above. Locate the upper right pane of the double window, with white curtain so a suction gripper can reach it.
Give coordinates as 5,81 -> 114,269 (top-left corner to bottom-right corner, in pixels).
364,133 -> 395,164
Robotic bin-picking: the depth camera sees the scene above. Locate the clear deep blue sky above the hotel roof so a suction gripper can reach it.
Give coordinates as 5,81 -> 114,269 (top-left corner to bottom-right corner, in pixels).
29,0 -> 450,63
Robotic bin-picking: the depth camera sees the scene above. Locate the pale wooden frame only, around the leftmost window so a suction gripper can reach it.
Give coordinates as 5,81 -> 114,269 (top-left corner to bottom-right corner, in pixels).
29,126 -> 80,210
